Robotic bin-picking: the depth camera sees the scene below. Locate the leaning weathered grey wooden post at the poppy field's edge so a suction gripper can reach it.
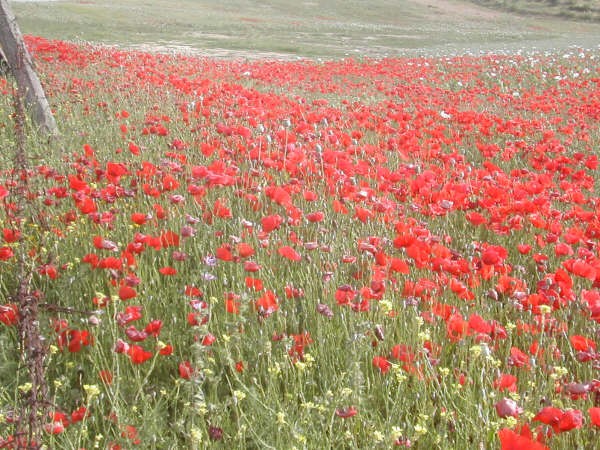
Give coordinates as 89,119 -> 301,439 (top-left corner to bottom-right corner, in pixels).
0,0 -> 58,135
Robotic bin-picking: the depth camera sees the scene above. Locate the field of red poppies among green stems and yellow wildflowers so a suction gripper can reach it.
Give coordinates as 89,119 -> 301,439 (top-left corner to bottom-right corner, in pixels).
0,36 -> 600,449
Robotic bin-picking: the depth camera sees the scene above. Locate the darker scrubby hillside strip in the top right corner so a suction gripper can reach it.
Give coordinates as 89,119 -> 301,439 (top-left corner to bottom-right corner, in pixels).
471,0 -> 600,22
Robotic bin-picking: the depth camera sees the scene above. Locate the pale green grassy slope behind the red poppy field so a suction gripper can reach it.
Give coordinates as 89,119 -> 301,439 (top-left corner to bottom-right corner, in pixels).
13,0 -> 600,57
